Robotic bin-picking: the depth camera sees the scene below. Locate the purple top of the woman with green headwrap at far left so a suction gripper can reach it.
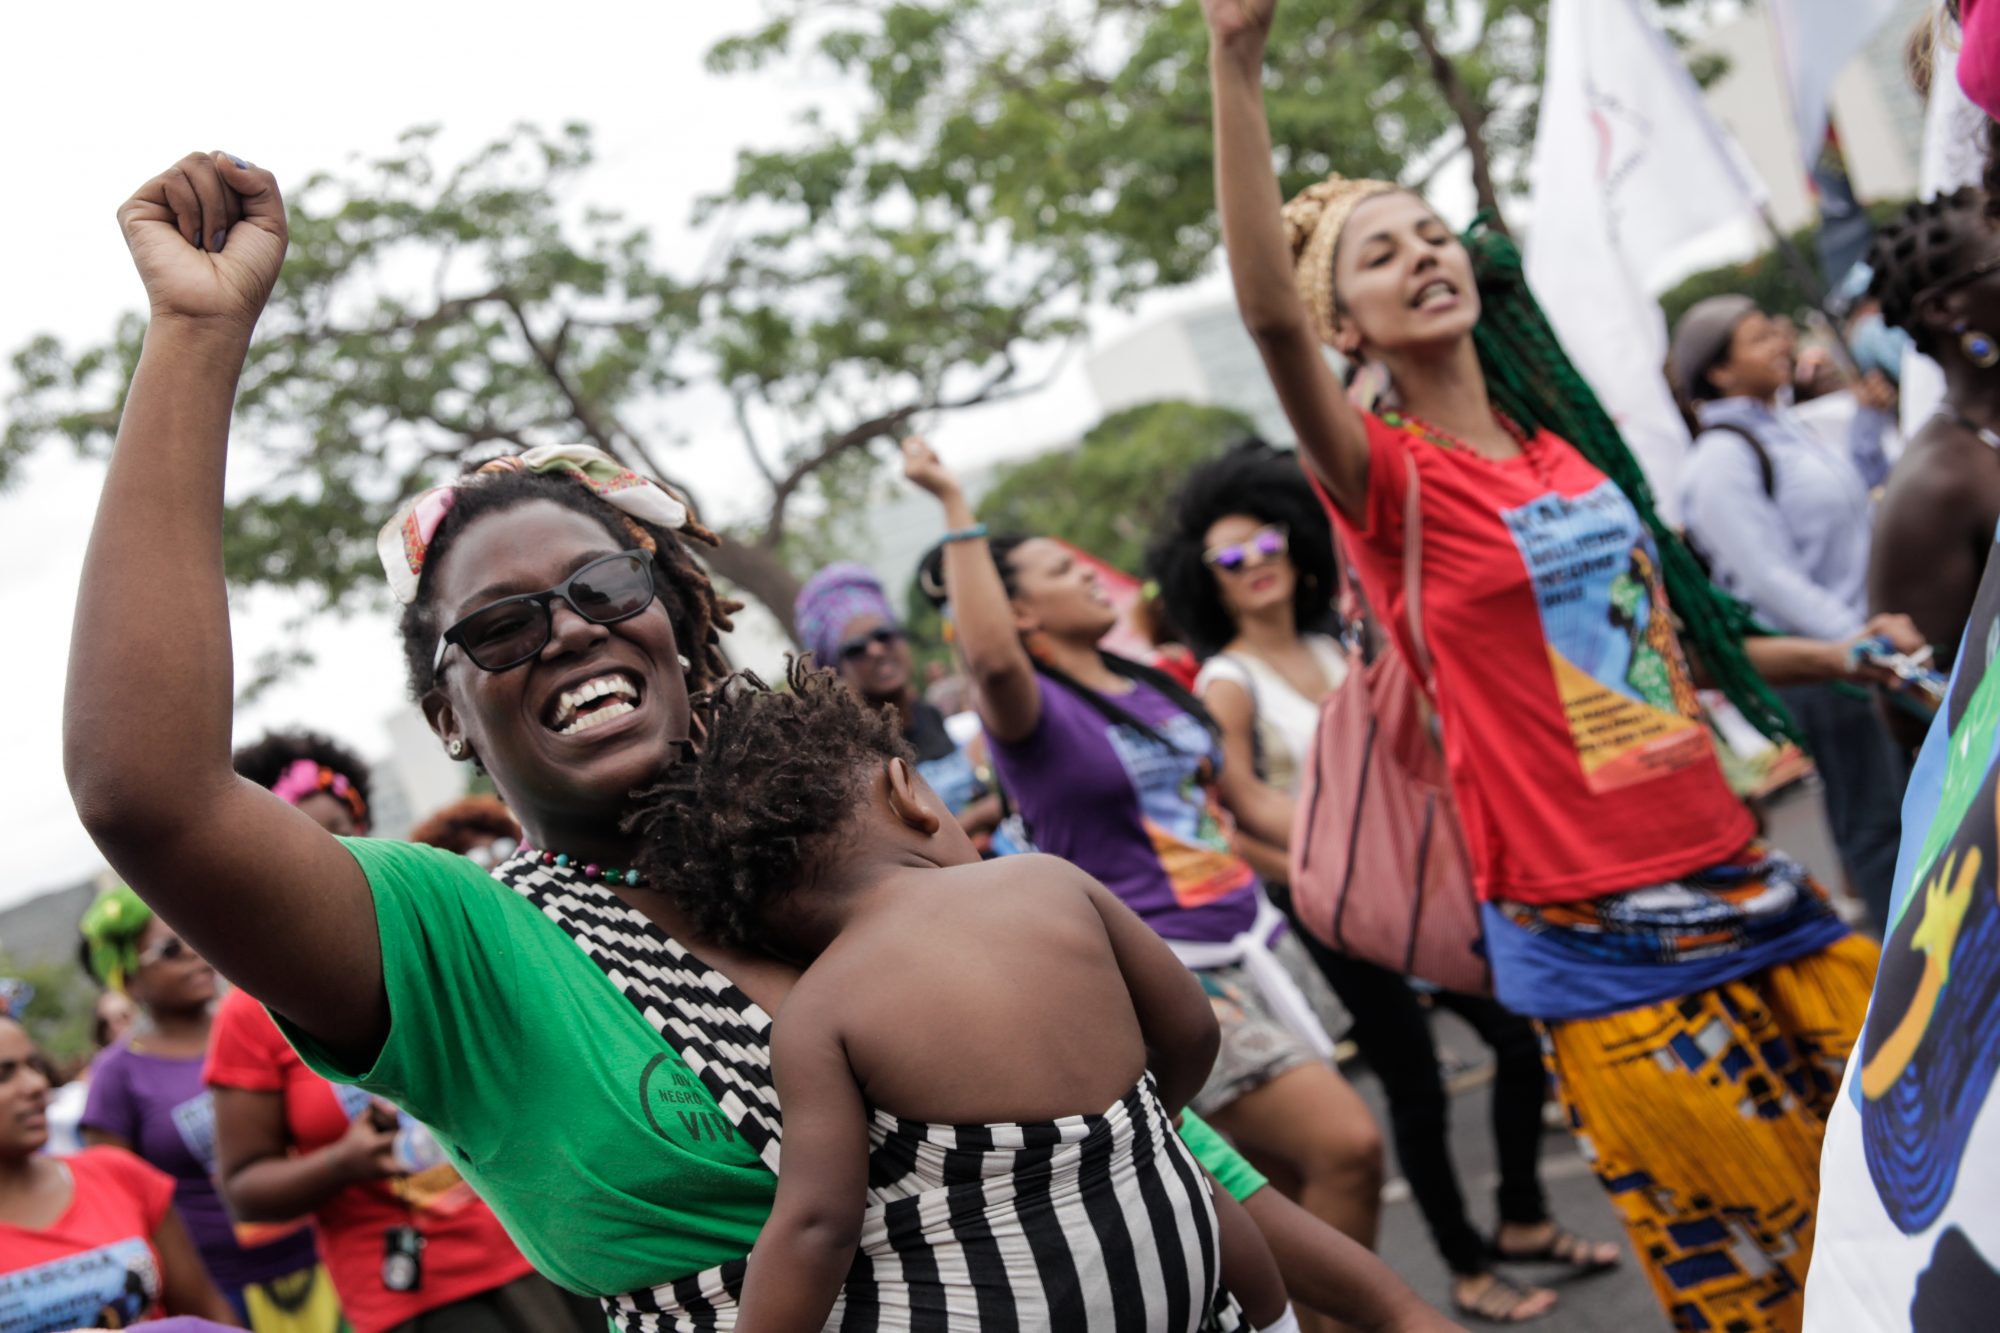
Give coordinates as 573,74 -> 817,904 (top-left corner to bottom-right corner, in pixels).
84,1041 -> 318,1291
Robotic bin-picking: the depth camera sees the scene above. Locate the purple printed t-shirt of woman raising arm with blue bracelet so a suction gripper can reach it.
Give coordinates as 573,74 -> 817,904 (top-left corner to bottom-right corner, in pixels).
992,677 -> 1256,943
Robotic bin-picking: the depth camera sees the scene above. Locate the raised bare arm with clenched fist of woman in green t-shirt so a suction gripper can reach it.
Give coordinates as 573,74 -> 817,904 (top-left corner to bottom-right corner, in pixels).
62,152 -> 388,1057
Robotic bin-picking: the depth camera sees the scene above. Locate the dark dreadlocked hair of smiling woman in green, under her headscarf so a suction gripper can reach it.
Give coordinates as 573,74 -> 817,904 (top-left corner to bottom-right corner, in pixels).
398,472 -> 742,699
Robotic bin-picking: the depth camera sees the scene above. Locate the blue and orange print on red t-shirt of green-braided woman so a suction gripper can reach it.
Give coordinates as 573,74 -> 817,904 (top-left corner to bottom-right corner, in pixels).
1500,480 -> 1710,793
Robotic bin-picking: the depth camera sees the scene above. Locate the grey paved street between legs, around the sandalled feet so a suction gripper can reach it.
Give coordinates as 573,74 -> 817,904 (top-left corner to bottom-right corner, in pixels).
1356,1000 -> 1668,1333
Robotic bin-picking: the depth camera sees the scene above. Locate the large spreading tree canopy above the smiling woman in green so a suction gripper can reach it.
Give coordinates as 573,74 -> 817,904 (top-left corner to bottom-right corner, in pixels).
0,0 -> 1736,644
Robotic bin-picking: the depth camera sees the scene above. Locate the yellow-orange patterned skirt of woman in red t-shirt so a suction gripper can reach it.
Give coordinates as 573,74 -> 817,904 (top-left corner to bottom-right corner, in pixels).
1542,935 -> 1880,1333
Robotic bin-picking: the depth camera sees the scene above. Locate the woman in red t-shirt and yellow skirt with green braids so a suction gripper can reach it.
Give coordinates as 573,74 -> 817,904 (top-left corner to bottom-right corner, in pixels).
1204,0 -> 1916,1329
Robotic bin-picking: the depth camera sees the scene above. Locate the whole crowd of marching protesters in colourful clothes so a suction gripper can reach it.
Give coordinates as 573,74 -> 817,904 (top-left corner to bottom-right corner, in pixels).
11,0 -> 2000,1333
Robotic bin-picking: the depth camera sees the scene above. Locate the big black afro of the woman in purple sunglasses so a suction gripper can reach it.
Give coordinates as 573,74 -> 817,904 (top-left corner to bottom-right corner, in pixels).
1146,438 -> 1340,658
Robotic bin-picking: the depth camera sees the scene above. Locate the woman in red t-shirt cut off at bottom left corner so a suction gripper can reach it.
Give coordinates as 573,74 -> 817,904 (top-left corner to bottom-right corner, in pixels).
0,1019 -> 238,1333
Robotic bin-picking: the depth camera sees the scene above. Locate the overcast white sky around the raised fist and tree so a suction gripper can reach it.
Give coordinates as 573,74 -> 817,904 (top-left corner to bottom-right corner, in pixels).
0,0 -> 1272,905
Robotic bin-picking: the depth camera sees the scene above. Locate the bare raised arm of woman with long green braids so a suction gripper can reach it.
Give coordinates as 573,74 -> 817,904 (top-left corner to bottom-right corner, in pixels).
1202,0 -> 1368,520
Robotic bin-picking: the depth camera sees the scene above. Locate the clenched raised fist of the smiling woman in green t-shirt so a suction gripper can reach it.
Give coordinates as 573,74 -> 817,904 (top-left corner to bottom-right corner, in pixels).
118,152 -> 286,334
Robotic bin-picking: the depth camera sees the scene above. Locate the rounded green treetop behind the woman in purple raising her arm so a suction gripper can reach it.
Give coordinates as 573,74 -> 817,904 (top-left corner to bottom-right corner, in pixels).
978,400 -> 1256,572
